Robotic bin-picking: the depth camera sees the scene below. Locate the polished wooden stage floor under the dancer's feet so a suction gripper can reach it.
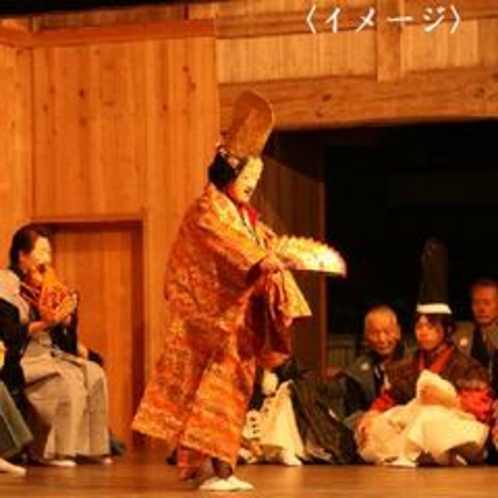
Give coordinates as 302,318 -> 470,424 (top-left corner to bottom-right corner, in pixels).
0,452 -> 498,498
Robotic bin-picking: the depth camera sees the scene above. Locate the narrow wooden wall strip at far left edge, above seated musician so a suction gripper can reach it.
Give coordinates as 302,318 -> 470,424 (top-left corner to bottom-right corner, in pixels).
0,44 -> 31,266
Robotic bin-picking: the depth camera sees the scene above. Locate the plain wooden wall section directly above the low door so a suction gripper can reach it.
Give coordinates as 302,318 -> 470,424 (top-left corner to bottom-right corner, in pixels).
33,40 -> 147,217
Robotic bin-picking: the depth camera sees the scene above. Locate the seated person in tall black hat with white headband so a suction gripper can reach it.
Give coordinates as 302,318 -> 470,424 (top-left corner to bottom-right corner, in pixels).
357,241 -> 492,466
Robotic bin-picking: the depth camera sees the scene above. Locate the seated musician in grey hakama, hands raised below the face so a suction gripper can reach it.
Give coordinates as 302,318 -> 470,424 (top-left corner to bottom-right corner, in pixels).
0,225 -> 109,467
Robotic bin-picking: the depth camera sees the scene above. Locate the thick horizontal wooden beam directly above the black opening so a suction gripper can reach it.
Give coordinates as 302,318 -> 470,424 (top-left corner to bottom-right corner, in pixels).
220,69 -> 498,130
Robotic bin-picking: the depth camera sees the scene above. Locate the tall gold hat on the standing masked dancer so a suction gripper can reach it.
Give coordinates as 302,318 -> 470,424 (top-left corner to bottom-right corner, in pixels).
218,90 -> 275,168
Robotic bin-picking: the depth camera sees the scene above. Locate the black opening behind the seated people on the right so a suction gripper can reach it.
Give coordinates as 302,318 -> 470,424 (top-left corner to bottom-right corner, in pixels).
324,121 -> 498,335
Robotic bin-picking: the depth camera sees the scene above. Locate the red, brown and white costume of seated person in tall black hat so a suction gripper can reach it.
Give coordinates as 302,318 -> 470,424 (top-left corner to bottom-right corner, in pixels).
359,344 -> 492,465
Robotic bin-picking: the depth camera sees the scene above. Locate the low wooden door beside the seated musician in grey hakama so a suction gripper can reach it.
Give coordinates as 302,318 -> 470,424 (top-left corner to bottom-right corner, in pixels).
50,223 -> 146,443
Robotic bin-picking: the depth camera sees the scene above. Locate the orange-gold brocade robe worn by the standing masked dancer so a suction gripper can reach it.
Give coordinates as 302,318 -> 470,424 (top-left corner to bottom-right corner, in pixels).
133,185 -> 311,465
